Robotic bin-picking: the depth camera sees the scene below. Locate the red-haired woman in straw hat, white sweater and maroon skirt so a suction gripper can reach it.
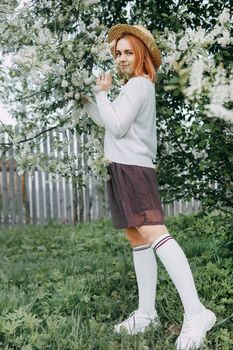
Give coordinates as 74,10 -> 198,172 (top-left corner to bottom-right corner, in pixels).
82,24 -> 216,350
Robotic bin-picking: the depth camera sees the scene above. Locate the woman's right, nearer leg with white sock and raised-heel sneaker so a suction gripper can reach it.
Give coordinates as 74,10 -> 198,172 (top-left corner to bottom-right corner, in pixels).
137,225 -> 216,350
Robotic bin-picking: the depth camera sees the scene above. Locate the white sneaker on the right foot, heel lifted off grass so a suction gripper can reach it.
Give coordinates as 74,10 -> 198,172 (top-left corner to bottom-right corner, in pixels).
176,309 -> 216,350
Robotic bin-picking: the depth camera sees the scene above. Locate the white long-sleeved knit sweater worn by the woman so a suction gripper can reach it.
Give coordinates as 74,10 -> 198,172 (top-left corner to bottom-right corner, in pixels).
85,77 -> 157,168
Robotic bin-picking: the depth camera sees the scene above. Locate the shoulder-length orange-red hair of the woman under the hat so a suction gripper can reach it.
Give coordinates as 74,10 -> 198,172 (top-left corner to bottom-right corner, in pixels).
113,34 -> 156,83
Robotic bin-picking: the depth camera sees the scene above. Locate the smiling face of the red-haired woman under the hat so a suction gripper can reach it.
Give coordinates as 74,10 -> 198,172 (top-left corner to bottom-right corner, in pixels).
116,38 -> 135,78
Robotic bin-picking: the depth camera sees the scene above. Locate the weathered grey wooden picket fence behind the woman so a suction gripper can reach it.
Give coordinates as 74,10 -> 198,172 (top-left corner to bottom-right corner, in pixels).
0,132 -> 200,226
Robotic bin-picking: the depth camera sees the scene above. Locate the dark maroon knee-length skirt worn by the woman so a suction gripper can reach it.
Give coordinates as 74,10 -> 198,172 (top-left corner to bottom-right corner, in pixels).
107,163 -> 164,229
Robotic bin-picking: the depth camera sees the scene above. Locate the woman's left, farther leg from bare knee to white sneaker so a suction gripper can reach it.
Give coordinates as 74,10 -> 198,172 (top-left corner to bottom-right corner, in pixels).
115,227 -> 157,334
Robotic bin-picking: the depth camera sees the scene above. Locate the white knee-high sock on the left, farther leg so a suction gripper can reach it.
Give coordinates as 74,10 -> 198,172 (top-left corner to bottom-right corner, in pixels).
133,245 -> 157,317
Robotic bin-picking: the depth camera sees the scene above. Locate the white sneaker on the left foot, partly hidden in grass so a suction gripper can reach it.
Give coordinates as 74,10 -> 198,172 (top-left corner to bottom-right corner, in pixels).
114,310 -> 159,335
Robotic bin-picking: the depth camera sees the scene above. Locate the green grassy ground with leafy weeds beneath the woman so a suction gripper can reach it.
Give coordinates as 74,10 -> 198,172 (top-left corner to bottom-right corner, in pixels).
0,215 -> 233,350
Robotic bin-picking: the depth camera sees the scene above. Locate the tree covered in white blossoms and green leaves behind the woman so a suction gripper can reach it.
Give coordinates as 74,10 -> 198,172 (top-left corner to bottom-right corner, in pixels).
0,0 -> 233,208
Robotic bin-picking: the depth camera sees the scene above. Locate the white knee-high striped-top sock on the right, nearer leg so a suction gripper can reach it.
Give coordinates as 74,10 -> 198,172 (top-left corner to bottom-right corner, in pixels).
152,234 -> 203,316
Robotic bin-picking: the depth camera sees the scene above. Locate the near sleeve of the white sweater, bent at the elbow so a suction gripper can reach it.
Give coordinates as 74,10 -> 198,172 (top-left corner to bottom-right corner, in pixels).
95,77 -> 145,138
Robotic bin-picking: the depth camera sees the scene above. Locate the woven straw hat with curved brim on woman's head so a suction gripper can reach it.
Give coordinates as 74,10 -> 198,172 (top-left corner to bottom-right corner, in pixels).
108,24 -> 161,70
